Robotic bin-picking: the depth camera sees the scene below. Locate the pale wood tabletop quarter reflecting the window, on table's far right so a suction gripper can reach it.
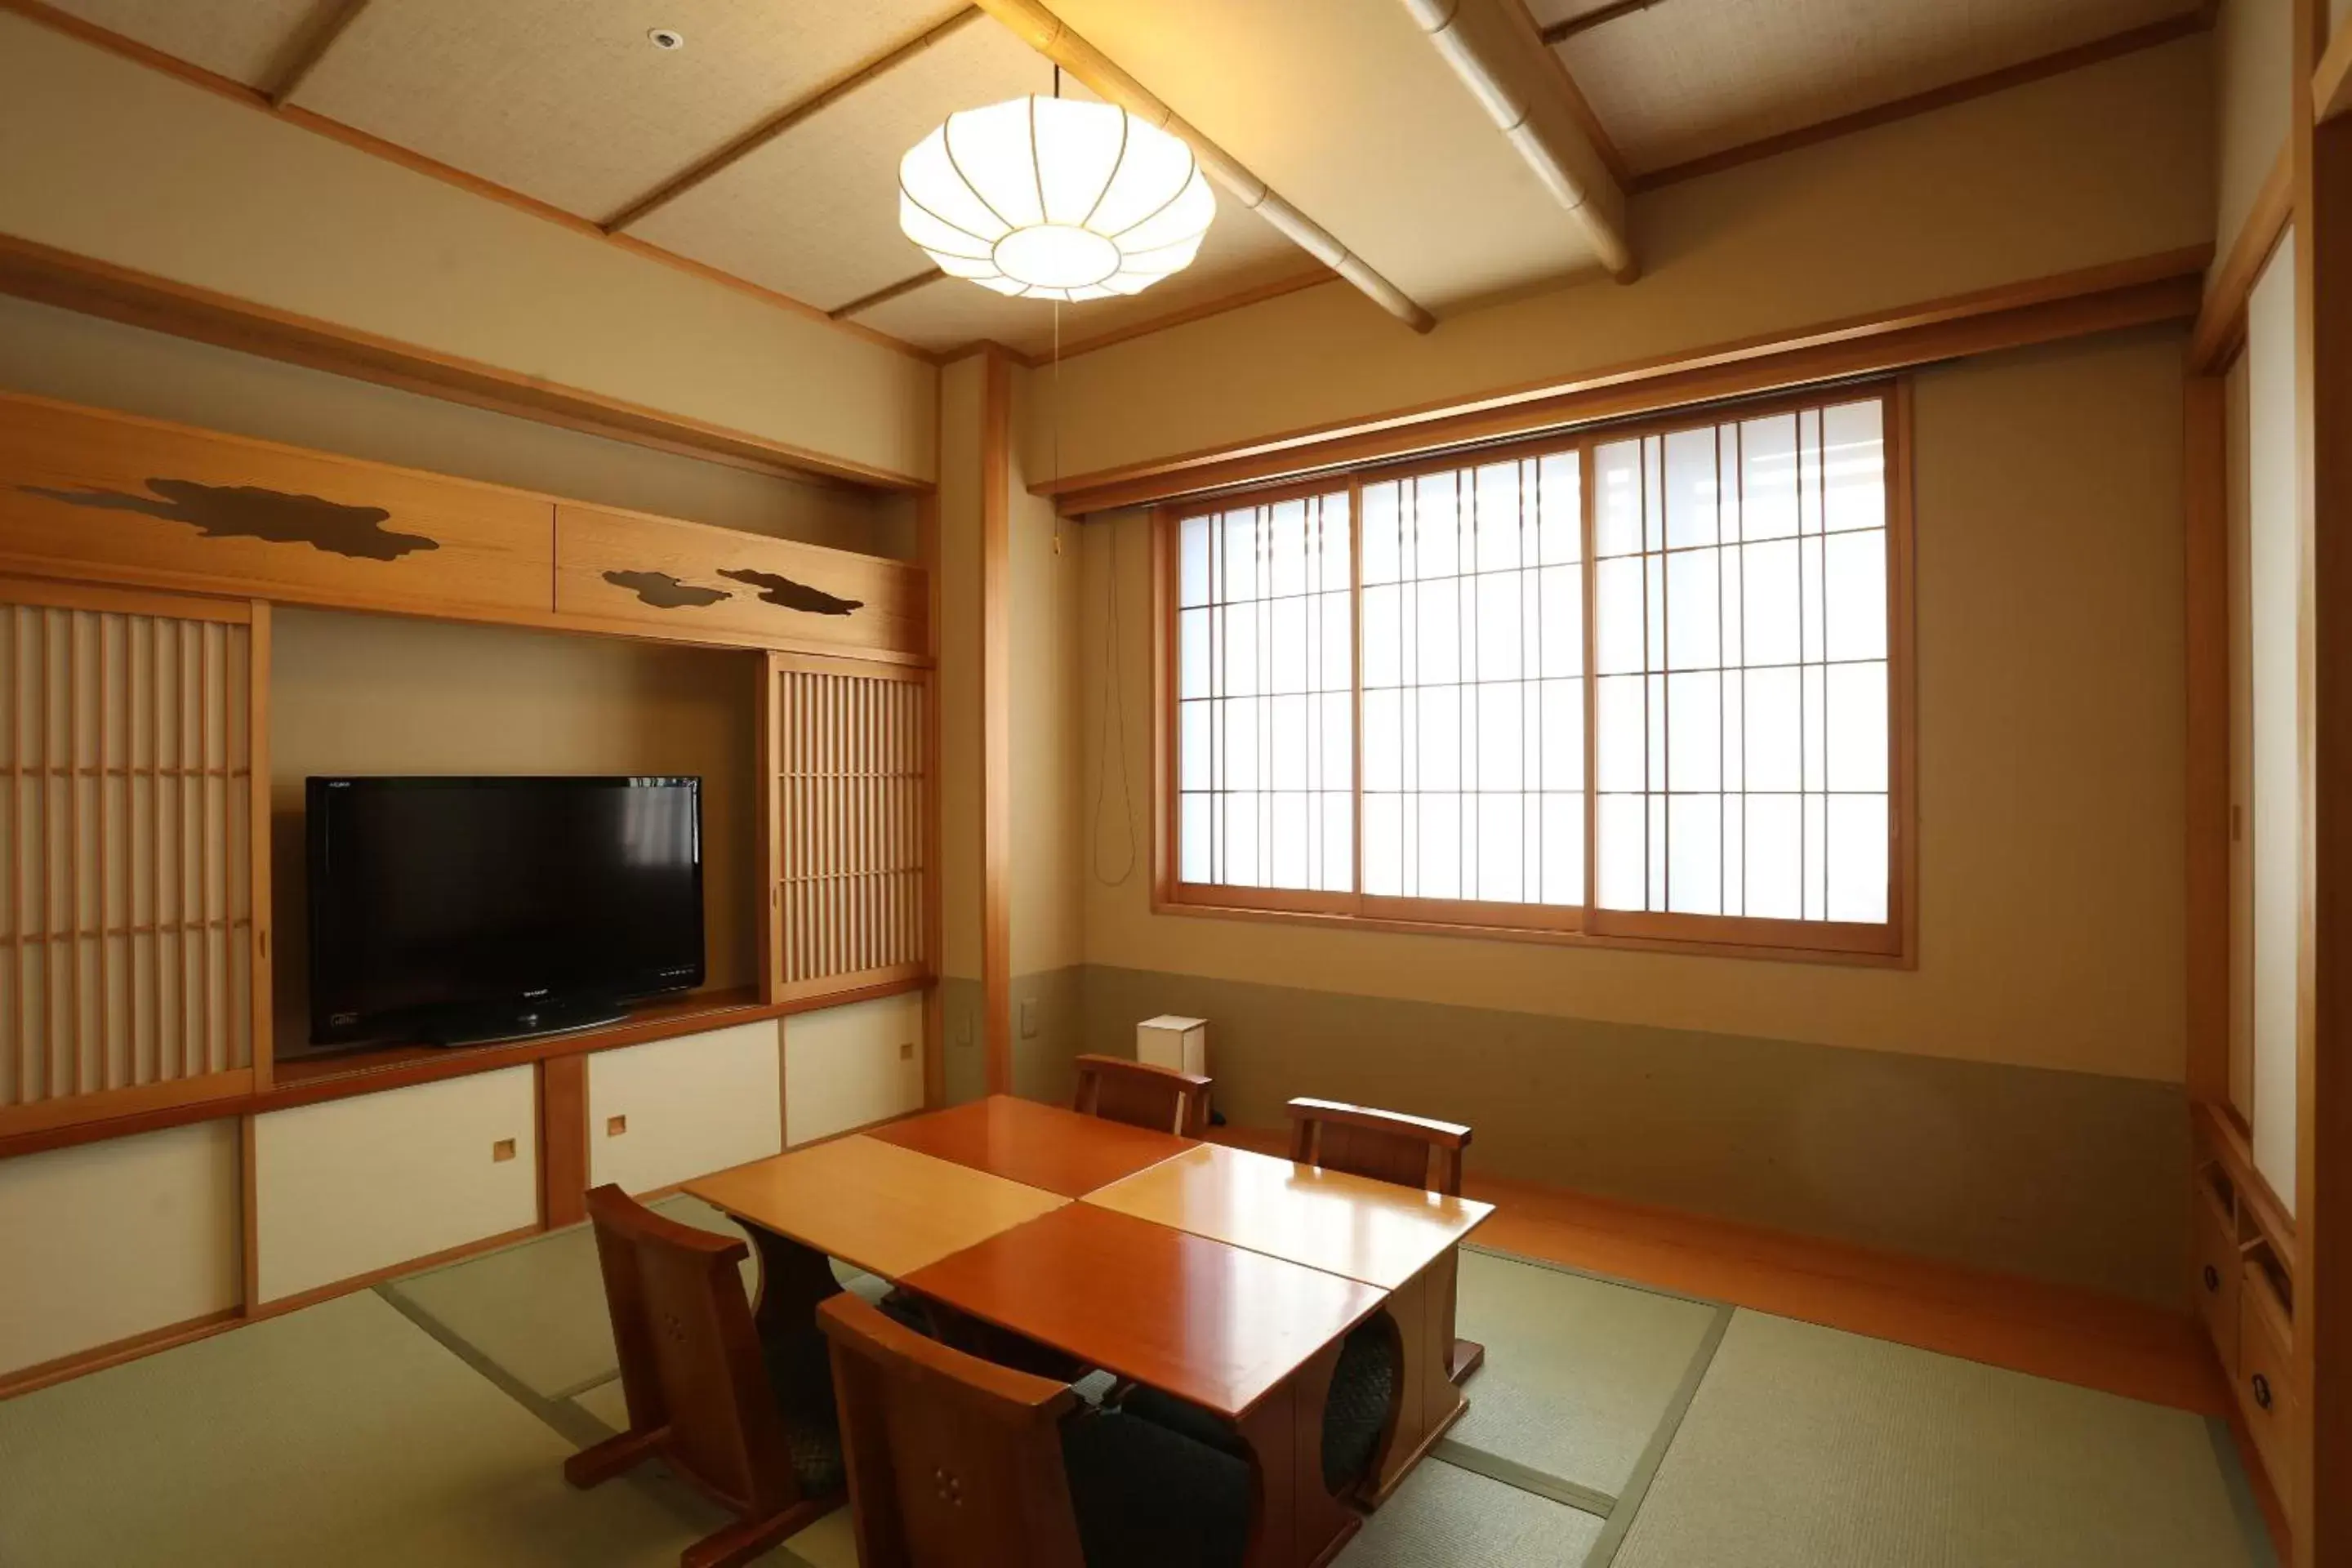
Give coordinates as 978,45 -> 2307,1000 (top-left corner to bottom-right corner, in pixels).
1087,1143 -> 1494,1290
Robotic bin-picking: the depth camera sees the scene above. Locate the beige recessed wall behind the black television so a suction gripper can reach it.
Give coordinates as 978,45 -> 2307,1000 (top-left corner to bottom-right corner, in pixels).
270,609 -> 760,1051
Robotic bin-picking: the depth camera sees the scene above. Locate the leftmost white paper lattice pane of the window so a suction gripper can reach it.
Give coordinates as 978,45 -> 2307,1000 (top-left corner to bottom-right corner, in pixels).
1176,492 -> 1355,893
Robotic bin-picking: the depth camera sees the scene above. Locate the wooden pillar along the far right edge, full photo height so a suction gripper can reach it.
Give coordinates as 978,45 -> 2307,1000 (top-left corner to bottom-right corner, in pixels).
2288,0 -> 2352,1568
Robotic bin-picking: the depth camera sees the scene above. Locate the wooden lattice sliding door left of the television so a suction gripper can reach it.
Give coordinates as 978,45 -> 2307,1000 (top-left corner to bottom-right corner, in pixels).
0,578 -> 268,1131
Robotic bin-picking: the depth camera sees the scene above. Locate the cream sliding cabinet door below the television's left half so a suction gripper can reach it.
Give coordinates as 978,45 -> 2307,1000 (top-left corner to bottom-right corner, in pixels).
249,1067 -> 539,1305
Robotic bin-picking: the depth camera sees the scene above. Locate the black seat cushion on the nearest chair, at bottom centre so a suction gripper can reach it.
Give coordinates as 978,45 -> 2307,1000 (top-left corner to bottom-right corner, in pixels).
1061,1410 -> 1249,1568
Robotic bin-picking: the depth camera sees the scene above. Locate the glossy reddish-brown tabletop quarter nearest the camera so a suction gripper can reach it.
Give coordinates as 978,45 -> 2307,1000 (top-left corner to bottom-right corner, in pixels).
906,1204 -> 1385,1418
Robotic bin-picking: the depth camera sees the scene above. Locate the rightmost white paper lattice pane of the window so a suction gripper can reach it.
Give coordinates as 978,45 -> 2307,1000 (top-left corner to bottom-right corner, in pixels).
1592,399 -> 1891,924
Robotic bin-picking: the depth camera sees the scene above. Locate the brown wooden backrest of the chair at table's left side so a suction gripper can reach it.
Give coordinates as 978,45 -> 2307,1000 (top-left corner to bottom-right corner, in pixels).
588,1185 -> 797,1514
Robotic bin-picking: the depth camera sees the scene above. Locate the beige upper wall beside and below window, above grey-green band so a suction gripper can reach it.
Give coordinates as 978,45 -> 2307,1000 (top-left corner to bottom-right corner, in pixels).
1080,332 -> 2183,1090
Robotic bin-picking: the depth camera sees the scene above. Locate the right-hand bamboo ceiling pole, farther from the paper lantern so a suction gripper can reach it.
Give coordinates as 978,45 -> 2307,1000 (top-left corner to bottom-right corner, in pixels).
1404,0 -> 1642,282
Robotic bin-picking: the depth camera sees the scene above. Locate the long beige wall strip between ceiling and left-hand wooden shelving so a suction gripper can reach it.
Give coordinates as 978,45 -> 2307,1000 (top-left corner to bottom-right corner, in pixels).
0,14 -> 936,479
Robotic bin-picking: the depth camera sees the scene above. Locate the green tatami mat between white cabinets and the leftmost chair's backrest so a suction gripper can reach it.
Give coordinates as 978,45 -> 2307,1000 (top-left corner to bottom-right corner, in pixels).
383,1194 -> 757,1399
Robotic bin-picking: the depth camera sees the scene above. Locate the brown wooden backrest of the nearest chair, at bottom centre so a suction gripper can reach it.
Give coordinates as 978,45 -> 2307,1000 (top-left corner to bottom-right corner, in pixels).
816,1293 -> 1085,1568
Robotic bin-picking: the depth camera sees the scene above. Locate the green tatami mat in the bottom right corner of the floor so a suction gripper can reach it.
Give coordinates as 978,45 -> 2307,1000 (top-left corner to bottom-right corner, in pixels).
1616,1312 -> 2248,1568
